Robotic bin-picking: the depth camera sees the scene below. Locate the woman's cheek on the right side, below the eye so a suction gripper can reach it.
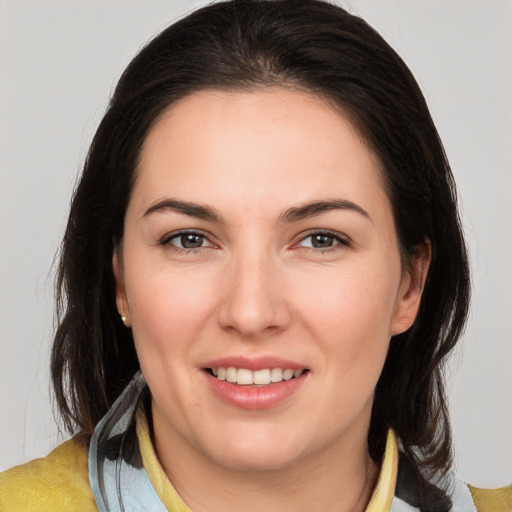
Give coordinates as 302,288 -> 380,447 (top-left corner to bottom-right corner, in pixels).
293,265 -> 399,362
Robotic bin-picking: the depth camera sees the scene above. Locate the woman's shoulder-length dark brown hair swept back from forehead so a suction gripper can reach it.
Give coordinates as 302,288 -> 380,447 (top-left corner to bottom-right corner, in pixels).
51,0 -> 470,504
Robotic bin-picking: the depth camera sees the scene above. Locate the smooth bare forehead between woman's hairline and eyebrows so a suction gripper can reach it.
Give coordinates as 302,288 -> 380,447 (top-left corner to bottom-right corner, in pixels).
134,88 -> 383,216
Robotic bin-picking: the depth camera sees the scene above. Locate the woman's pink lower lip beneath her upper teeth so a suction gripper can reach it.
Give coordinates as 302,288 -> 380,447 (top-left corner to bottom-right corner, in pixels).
205,372 -> 309,410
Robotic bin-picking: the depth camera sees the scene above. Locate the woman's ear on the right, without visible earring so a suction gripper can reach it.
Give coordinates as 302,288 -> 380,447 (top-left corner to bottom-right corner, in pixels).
391,240 -> 432,336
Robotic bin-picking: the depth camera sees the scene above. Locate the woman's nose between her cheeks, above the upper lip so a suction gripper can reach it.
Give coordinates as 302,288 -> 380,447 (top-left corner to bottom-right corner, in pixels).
218,253 -> 291,338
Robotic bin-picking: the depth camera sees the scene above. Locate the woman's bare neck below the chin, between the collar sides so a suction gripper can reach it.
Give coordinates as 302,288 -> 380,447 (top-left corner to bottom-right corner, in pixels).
154,412 -> 378,512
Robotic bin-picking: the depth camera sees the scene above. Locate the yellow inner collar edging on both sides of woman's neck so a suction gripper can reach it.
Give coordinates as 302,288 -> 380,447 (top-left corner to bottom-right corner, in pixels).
137,410 -> 398,512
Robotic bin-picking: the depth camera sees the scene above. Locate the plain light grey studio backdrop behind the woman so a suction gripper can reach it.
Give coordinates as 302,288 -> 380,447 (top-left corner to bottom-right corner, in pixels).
0,0 -> 512,486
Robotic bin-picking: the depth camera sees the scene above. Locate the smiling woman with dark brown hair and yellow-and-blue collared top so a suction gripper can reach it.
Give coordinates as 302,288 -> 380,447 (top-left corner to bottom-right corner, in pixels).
0,0 -> 510,512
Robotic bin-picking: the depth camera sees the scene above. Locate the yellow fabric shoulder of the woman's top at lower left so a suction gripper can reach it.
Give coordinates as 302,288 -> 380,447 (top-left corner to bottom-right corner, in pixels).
0,437 -> 97,512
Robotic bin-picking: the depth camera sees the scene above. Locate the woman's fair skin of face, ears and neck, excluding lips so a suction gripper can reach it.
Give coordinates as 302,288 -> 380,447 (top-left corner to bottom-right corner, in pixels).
113,88 -> 428,512
